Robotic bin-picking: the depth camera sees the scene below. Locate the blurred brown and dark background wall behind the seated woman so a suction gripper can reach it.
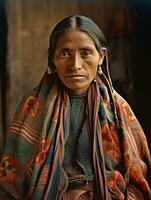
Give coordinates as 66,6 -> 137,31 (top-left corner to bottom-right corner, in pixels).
0,0 -> 151,155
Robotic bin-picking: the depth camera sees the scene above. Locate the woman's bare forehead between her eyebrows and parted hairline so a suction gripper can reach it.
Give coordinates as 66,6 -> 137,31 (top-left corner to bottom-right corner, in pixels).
56,30 -> 95,48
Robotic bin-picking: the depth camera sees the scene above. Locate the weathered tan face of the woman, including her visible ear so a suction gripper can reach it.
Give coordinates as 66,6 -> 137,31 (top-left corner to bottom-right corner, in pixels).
54,30 -> 104,94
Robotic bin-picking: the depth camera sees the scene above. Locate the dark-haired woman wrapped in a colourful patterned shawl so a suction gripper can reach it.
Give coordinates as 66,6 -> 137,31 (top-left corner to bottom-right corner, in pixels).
0,16 -> 151,200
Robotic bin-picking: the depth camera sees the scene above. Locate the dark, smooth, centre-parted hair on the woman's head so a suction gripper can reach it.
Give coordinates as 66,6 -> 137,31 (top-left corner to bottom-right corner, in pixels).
48,15 -> 107,71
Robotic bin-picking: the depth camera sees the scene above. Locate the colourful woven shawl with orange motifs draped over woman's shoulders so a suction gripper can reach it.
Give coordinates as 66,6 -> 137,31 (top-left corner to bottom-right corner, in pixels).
0,73 -> 151,200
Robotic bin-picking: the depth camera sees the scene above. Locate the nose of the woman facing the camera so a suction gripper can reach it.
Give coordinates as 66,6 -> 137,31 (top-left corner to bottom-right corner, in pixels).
69,53 -> 83,70
